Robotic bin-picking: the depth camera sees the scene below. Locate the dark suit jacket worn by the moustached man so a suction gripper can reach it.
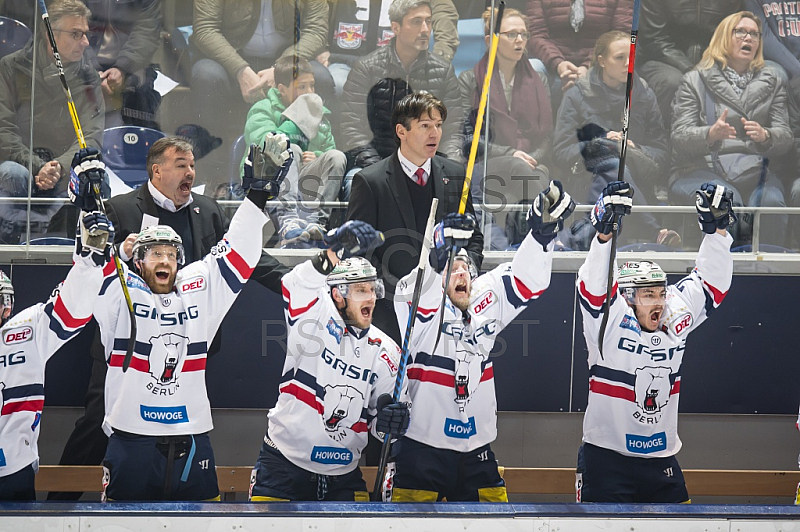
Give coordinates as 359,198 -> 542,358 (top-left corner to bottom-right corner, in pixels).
105,184 -> 289,294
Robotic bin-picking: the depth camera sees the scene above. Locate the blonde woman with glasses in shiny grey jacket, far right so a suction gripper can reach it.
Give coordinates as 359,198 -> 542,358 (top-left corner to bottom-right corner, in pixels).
670,11 -> 792,244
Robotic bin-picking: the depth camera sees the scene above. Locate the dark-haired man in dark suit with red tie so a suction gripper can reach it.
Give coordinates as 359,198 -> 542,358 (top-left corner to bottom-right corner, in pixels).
347,92 -> 483,345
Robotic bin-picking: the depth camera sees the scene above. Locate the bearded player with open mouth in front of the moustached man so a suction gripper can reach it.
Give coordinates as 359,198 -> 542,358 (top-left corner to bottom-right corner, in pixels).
65,135 -> 292,500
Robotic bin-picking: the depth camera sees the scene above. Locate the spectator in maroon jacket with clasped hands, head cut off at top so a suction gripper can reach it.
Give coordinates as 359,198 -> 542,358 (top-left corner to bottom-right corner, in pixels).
528,0 -> 633,100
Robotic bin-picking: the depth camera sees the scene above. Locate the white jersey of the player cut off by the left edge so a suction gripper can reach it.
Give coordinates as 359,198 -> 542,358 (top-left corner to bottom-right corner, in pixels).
0,257 -> 116,477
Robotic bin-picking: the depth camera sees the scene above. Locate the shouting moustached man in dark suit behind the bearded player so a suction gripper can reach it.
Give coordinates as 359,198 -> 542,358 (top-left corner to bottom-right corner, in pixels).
48,137 -> 289,500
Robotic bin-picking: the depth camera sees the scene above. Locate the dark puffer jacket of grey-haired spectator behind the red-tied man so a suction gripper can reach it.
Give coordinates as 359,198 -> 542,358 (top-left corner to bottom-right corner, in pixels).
337,39 -> 462,160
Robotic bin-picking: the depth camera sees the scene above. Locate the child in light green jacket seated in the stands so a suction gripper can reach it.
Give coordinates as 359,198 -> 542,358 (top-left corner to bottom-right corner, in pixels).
244,56 -> 347,247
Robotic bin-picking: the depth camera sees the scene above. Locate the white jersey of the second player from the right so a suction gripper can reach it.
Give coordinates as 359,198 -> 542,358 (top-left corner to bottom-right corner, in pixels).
394,234 -> 553,452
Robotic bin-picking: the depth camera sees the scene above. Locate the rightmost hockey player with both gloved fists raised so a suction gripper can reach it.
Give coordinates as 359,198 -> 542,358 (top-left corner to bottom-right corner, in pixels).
575,181 -> 735,503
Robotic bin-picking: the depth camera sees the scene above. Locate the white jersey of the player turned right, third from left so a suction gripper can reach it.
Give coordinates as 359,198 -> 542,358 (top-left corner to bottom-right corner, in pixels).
268,261 -> 400,475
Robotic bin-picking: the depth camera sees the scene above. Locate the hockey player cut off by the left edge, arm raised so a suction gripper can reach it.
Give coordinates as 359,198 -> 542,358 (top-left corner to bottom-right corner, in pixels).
0,212 -> 116,500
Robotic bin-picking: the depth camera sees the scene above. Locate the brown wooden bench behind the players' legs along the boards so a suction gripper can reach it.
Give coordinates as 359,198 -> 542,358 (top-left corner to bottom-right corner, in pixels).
36,466 -> 800,500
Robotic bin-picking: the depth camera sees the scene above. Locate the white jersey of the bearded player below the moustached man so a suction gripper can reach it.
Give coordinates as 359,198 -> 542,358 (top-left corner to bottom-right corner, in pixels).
95,199 -> 267,436
